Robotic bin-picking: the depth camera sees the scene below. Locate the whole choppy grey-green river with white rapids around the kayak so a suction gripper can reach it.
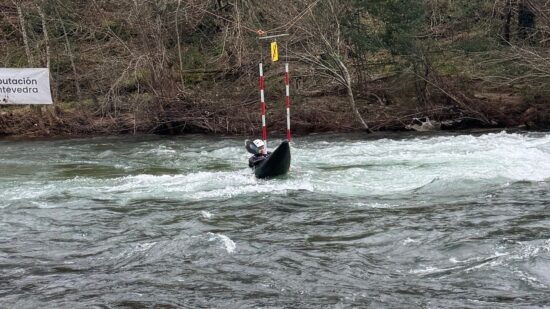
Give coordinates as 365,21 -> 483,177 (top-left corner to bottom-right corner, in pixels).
0,132 -> 550,308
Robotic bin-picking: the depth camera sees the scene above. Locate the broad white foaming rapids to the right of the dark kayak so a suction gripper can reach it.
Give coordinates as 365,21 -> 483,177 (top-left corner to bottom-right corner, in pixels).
293,133 -> 550,195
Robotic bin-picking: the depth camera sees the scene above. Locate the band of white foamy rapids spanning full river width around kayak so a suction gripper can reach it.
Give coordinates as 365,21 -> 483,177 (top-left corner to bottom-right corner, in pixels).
0,133 -> 550,208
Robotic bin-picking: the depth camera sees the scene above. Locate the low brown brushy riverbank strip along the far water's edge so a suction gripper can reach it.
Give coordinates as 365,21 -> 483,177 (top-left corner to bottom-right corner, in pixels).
0,89 -> 550,137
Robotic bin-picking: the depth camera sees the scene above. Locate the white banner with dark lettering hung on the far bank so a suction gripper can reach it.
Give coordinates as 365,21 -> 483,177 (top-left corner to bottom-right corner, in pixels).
0,68 -> 53,104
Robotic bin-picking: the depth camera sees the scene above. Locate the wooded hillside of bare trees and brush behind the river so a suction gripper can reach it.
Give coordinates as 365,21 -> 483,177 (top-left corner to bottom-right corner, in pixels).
0,0 -> 550,135
